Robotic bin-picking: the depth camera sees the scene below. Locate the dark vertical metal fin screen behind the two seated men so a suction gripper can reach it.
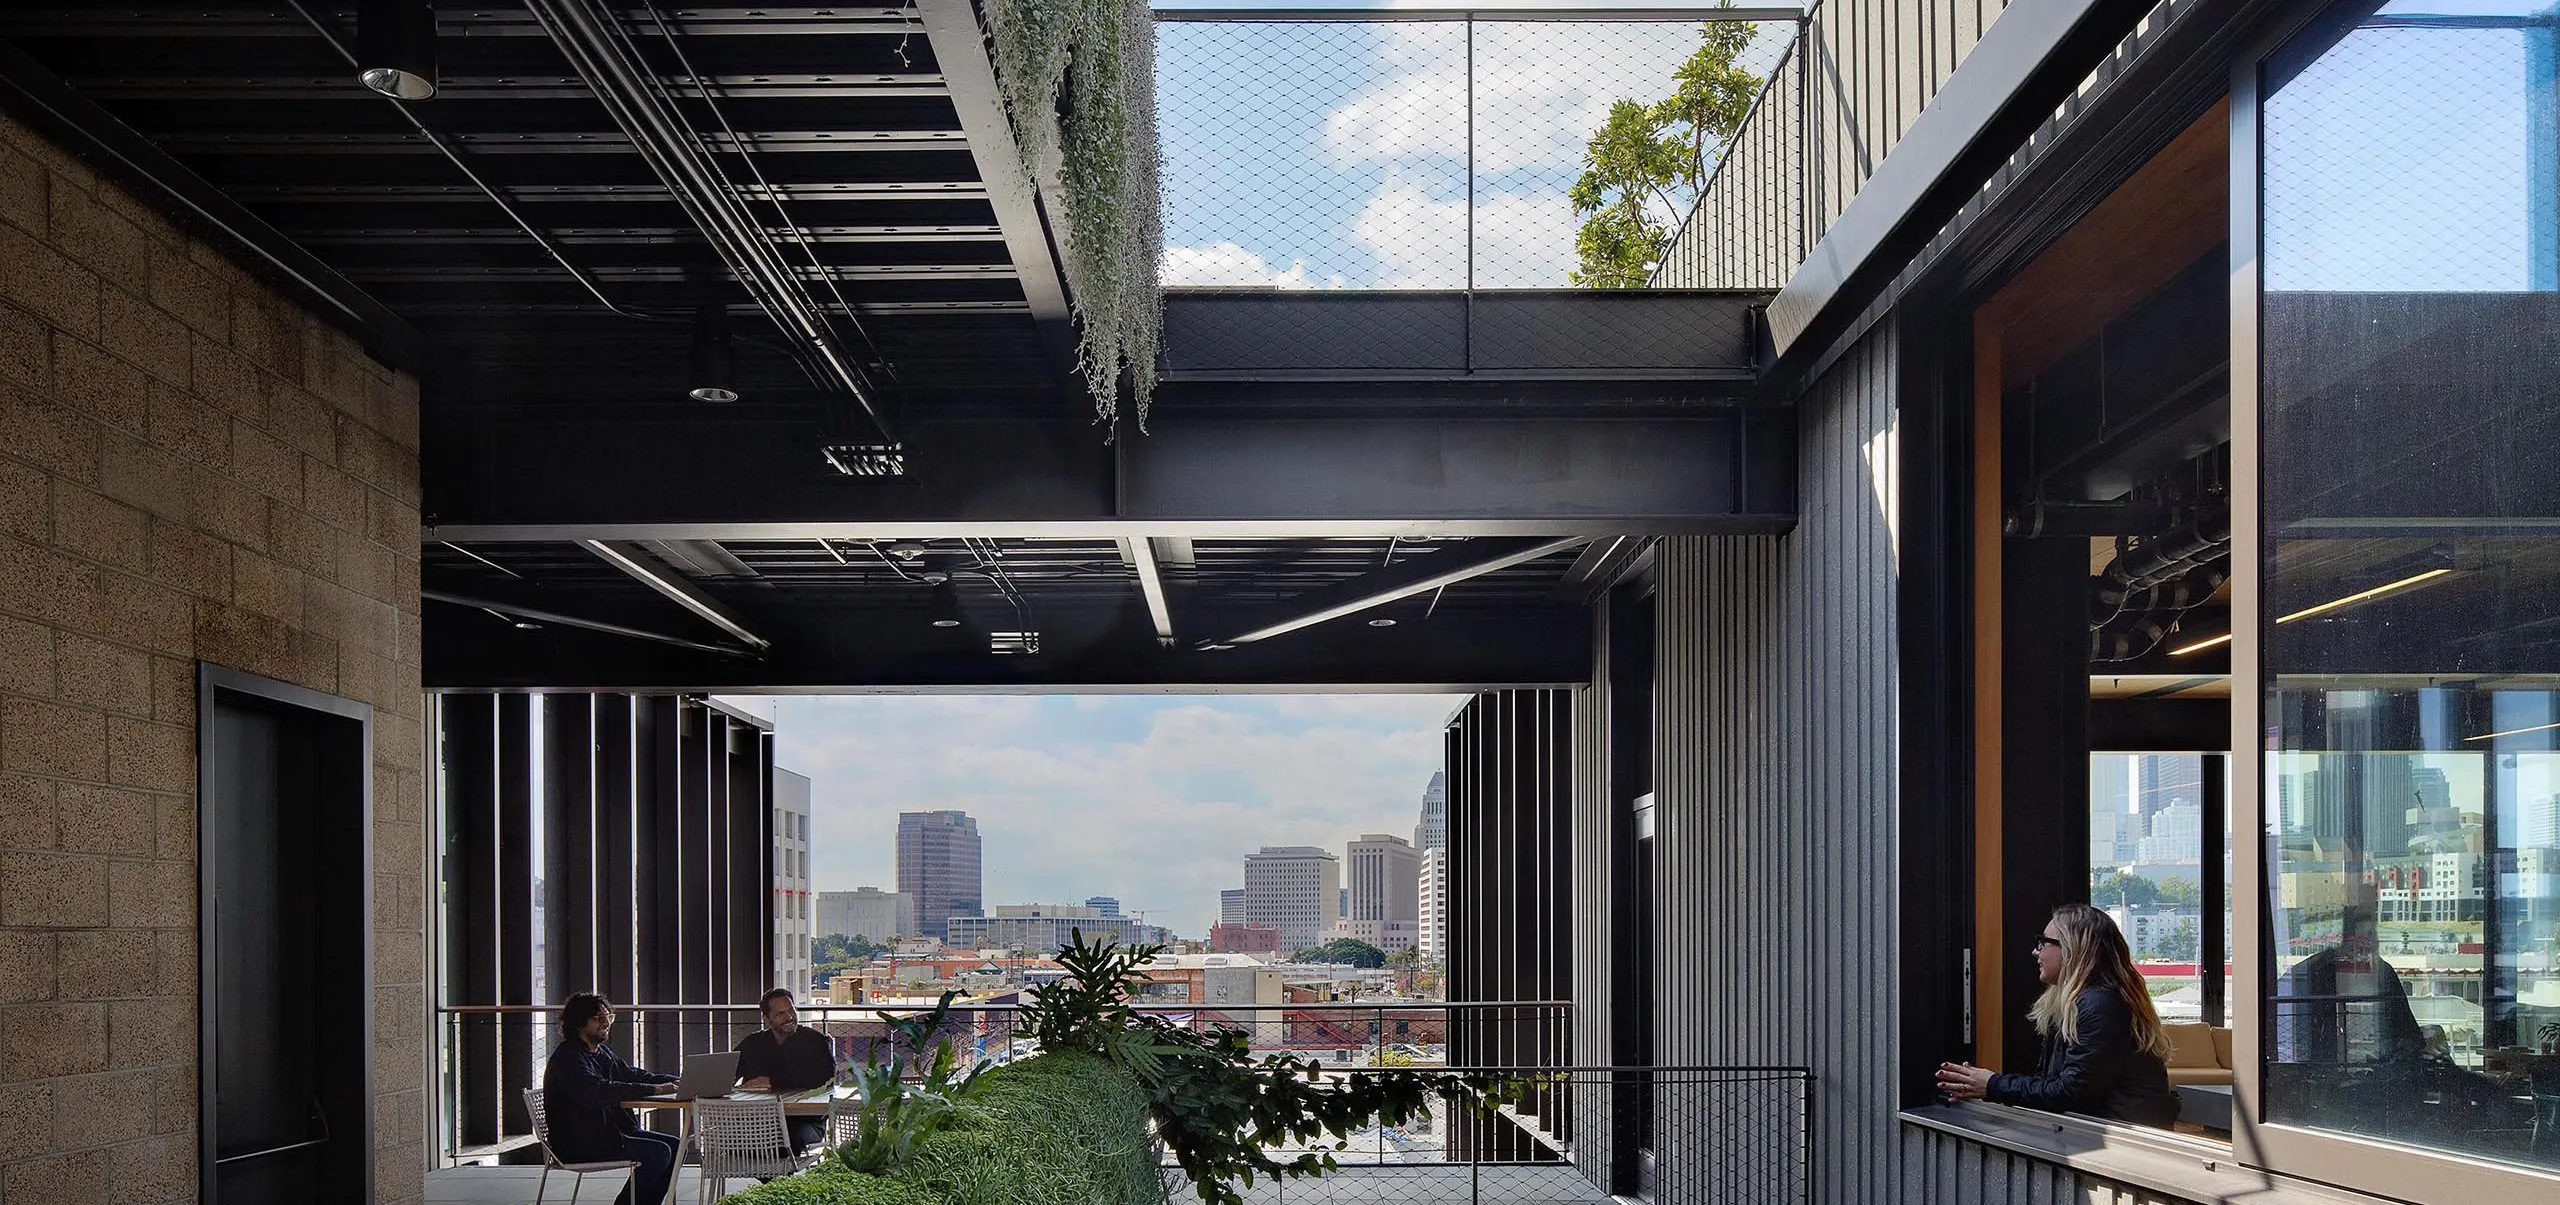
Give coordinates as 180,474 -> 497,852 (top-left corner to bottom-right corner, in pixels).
435,693 -> 773,1154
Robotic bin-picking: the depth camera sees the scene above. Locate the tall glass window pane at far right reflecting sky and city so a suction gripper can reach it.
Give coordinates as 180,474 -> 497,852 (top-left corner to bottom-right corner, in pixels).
2258,0 -> 2560,1167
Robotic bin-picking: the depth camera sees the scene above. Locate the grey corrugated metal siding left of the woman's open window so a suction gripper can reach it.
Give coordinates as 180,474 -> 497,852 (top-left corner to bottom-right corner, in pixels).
1648,330 -> 1902,1205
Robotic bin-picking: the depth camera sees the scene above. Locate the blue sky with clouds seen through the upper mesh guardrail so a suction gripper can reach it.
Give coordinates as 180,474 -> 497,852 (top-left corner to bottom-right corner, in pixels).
1157,5 -> 1789,289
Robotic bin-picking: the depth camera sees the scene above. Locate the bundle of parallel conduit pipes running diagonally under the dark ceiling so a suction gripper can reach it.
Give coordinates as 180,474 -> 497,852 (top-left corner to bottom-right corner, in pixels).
525,0 -> 896,443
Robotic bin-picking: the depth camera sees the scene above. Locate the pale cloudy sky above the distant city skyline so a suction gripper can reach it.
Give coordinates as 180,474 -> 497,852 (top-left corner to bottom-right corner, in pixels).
748,696 -> 1464,936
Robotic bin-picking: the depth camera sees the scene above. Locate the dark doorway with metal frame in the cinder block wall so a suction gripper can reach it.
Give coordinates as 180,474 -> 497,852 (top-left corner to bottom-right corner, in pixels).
197,665 -> 374,1205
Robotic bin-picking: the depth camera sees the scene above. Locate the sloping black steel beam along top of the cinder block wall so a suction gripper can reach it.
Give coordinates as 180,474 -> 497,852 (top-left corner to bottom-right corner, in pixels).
0,41 -> 428,371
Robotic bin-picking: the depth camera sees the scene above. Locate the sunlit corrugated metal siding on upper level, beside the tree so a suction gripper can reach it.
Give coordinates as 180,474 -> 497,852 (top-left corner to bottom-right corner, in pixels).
1654,0 -> 2007,289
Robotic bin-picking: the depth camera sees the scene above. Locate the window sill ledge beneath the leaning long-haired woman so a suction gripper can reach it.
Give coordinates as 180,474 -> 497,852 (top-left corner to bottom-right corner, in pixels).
1900,1103 -> 2388,1205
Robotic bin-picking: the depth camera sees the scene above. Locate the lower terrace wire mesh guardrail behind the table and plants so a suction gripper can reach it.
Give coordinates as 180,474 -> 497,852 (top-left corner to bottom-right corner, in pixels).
438,1000 -> 1812,1205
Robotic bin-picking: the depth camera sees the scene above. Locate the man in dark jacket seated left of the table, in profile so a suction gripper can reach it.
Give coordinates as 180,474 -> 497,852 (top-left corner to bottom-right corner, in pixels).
543,993 -> 678,1205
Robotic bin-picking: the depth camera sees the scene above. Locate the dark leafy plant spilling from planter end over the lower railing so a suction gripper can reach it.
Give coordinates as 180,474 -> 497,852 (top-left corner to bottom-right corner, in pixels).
1029,931 -> 1526,1205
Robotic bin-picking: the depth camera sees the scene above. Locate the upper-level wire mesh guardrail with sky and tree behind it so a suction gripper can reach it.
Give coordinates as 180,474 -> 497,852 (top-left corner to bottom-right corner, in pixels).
1157,10 -> 1795,292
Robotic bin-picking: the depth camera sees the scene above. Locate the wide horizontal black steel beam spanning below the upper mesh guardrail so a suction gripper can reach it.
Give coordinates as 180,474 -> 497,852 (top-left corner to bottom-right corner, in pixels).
425,409 -> 1795,542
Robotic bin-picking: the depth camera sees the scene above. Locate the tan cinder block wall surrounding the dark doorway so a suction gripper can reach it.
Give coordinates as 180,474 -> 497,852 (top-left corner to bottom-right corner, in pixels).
0,108 -> 428,1205
